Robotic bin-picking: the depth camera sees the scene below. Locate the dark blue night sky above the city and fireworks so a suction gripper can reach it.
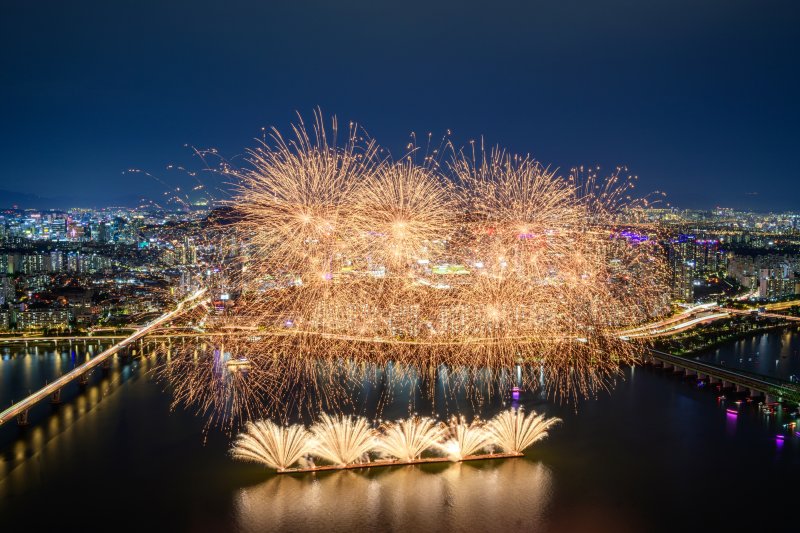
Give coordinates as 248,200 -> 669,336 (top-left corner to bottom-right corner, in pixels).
0,0 -> 800,210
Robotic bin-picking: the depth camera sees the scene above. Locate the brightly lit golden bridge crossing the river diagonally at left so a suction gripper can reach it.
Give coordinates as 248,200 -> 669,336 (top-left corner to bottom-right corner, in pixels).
0,289 -> 206,426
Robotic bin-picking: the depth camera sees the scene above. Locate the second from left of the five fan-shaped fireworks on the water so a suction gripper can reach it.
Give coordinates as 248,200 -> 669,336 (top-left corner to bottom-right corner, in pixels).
311,413 -> 375,466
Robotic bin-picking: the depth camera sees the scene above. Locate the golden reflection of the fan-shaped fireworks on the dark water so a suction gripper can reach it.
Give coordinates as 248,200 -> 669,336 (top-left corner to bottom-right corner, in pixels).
235,459 -> 553,531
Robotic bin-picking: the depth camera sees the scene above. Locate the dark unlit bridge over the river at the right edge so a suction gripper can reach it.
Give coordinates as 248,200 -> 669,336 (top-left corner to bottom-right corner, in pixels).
644,350 -> 800,405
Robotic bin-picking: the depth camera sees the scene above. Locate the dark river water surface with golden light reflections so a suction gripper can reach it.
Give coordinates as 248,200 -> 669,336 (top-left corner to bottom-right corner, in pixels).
0,333 -> 800,532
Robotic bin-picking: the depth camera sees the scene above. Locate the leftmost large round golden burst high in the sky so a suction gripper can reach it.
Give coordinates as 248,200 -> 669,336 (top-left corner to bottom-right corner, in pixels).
233,110 -> 377,282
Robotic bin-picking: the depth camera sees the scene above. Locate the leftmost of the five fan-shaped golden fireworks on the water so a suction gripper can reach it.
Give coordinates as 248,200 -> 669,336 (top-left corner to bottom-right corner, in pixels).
231,420 -> 313,471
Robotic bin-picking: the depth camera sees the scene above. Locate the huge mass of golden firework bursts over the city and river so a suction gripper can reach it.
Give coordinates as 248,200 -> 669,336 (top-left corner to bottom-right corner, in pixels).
156,114 -> 666,428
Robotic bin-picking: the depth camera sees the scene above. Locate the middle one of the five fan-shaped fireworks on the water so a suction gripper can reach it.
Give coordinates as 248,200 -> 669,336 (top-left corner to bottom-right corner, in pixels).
375,417 -> 445,461
